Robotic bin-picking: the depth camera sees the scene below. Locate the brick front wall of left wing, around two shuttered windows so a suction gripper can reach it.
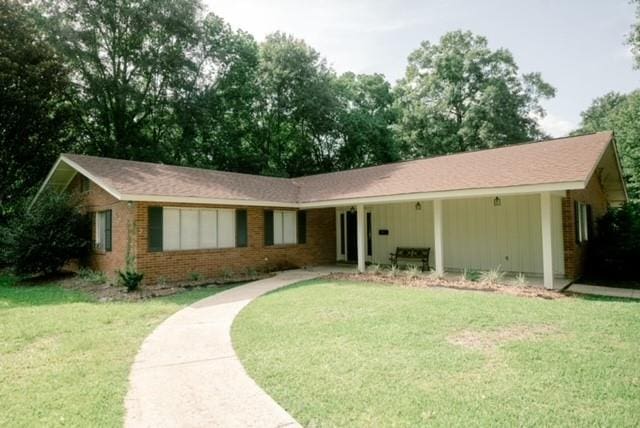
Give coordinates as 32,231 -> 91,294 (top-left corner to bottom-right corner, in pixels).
136,202 -> 336,283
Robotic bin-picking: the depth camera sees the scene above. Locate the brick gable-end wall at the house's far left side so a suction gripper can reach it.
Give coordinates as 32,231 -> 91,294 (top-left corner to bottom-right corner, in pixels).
69,174 -> 136,279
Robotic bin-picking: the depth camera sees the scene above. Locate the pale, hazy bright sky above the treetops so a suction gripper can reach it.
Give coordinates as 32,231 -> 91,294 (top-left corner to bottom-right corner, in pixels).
205,0 -> 640,137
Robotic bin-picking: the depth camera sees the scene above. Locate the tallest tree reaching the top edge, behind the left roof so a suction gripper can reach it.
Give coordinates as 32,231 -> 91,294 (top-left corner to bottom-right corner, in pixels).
44,0 -> 208,160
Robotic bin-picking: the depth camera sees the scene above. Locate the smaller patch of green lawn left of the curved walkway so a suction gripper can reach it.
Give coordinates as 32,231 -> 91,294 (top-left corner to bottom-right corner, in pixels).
0,275 -> 230,427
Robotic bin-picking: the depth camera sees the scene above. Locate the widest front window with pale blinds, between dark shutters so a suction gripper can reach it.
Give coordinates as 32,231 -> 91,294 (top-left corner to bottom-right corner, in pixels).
159,207 -> 239,251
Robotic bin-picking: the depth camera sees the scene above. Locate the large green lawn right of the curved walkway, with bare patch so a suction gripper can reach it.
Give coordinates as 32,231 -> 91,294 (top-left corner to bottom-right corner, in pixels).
232,280 -> 640,427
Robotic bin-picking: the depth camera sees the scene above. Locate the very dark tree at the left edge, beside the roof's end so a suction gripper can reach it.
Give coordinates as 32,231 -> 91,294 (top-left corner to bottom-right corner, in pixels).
0,0 -> 72,221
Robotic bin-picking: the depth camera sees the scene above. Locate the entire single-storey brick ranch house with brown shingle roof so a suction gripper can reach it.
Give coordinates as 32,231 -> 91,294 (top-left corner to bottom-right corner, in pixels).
34,132 -> 627,288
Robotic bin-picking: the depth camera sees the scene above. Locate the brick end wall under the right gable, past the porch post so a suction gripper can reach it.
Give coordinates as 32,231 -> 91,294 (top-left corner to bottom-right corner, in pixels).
562,174 -> 608,279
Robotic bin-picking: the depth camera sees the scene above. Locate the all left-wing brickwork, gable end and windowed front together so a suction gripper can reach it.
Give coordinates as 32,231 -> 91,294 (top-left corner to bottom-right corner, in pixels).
69,175 -> 336,283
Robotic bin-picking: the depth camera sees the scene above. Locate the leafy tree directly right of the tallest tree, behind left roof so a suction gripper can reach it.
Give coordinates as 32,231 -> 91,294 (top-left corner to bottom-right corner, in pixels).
170,15 -> 262,173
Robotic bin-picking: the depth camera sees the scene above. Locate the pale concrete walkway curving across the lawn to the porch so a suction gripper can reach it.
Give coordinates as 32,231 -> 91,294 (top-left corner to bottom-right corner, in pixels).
124,269 -> 329,428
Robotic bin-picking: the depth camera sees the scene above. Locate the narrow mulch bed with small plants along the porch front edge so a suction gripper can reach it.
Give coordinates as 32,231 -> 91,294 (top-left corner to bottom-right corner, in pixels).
328,272 -> 567,300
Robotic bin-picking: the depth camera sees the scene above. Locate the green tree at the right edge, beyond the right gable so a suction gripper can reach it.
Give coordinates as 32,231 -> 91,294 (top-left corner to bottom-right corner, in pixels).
575,90 -> 640,199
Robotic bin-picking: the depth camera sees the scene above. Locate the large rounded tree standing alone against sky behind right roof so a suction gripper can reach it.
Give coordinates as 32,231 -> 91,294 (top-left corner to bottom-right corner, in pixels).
396,31 -> 555,157
